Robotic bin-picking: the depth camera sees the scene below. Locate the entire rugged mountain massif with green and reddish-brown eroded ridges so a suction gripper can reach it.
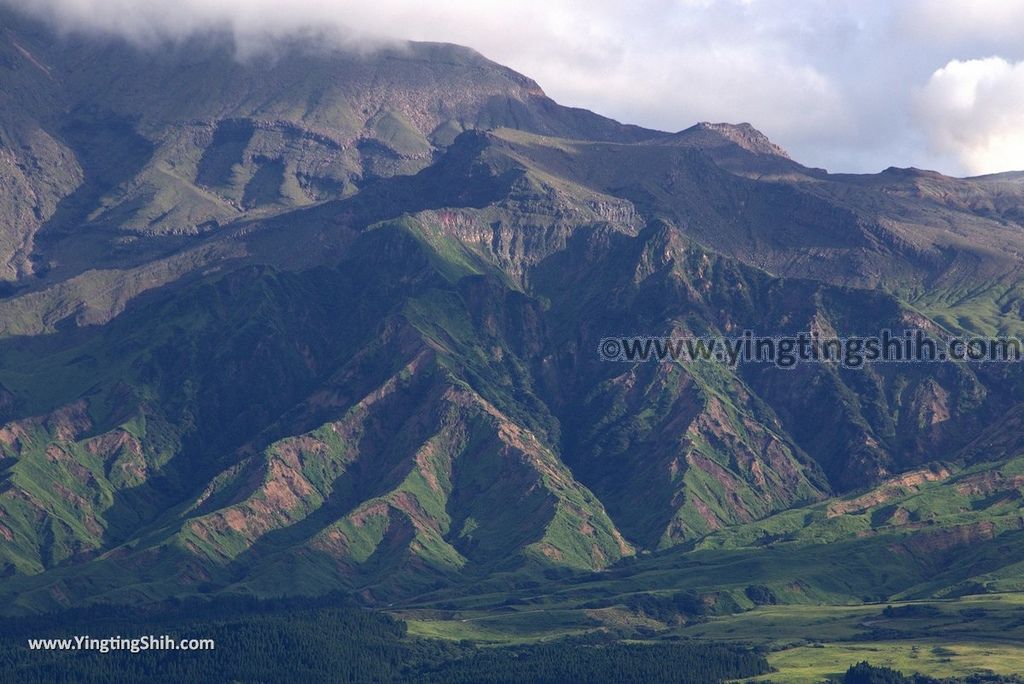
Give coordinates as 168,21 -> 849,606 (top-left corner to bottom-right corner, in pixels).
0,5 -> 1024,638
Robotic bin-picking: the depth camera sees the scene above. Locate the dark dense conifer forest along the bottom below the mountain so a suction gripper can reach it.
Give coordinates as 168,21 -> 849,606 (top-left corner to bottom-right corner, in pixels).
0,595 -> 769,684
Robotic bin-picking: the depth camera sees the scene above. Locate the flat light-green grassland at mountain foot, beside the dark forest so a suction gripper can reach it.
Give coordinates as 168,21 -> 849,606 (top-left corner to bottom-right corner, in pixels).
399,593 -> 1024,683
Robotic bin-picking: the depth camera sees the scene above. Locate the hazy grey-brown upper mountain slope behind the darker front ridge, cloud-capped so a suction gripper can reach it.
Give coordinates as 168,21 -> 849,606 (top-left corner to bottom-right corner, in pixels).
0,8 -> 654,282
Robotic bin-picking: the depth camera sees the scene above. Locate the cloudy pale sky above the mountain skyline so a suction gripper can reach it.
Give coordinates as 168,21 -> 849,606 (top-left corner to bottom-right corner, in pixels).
5,0 -> 1024,175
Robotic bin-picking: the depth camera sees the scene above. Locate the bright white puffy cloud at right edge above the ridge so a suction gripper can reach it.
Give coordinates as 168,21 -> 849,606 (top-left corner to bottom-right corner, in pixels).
916,57 -> 1024,174
